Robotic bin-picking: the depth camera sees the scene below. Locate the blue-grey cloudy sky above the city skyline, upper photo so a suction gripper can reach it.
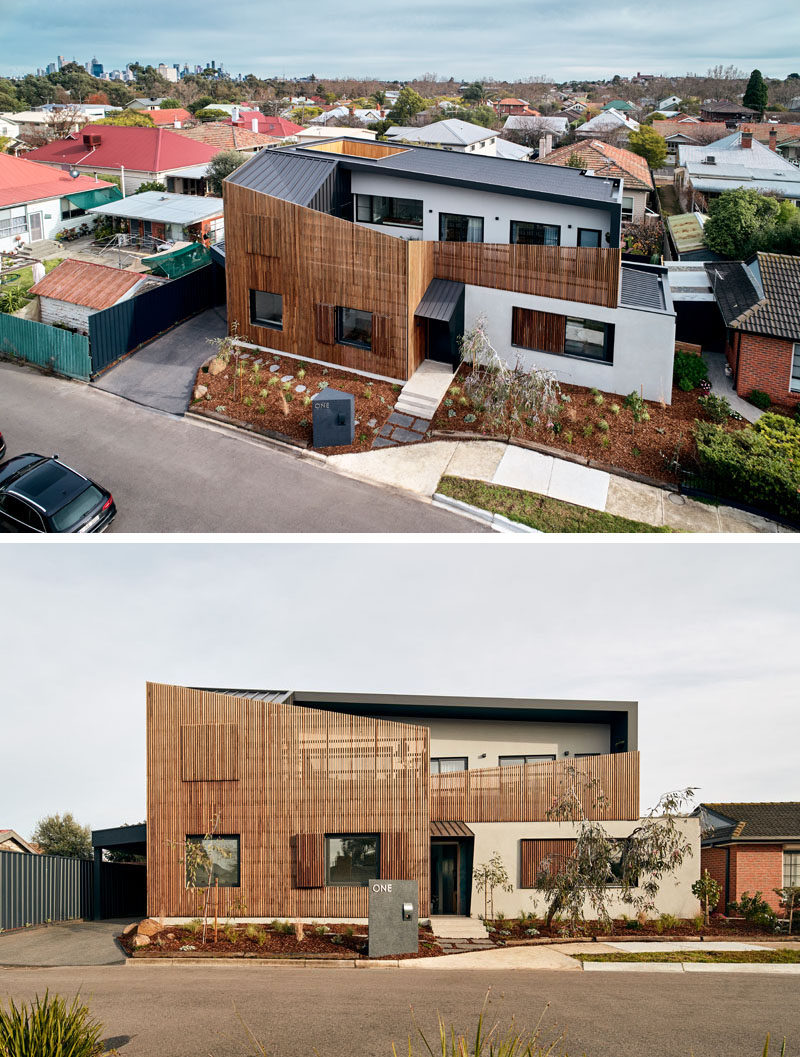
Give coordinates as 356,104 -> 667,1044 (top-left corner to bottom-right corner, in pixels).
0,0 -> 798,79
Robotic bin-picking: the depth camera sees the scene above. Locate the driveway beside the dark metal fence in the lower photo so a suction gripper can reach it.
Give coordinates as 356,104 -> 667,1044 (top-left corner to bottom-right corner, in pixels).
0,917 -> 131,967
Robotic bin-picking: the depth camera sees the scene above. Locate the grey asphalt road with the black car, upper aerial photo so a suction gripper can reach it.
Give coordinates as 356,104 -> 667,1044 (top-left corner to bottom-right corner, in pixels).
0,363 -> 487,533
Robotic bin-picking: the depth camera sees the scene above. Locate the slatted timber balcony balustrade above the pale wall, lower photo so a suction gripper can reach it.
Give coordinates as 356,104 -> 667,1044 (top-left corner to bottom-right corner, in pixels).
430,752 -> 639,822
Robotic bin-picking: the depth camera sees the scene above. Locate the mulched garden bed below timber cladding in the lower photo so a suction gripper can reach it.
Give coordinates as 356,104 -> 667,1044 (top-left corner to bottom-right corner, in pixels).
117,922 -> 443,961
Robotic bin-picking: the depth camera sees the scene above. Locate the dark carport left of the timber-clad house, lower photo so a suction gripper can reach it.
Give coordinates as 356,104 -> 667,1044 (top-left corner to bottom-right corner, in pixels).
92,823 -> 147,921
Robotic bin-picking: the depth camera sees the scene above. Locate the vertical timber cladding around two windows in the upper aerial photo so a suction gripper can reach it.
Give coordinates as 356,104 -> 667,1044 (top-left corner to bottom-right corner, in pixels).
224,184 -> 418,381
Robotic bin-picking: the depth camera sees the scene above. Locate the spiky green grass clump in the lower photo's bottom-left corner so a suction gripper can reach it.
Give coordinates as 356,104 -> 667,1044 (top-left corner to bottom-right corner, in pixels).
0,991 -> 104,1057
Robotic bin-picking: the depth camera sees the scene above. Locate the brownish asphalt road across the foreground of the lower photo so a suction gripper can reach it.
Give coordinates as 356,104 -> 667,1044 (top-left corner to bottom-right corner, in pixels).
0,965 -> 800,1057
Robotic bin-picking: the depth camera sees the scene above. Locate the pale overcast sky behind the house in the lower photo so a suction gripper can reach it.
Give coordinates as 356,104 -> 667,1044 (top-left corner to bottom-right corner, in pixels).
0,536 -> 800,837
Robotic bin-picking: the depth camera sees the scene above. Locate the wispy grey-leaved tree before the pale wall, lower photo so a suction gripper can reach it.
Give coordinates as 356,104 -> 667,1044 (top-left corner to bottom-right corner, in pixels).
535,766 -> 694,934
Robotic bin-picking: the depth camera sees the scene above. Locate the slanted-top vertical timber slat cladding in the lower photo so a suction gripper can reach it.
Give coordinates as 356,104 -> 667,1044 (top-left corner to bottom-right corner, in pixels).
147,684 -> 430,917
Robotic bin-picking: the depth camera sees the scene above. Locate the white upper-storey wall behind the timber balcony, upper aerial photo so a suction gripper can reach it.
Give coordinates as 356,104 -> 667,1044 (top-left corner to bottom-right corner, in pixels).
351,172 -> 609,246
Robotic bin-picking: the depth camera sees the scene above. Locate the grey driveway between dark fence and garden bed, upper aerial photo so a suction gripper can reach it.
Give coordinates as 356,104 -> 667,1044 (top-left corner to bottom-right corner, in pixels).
94,307 -> 227,414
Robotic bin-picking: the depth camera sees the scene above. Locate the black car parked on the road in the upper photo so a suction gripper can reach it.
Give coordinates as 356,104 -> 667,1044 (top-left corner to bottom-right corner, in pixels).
0,452 -> 116,533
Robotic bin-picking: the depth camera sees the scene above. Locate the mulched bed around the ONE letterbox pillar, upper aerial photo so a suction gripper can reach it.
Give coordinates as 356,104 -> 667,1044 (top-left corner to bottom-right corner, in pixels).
191,350 -> 401,455
